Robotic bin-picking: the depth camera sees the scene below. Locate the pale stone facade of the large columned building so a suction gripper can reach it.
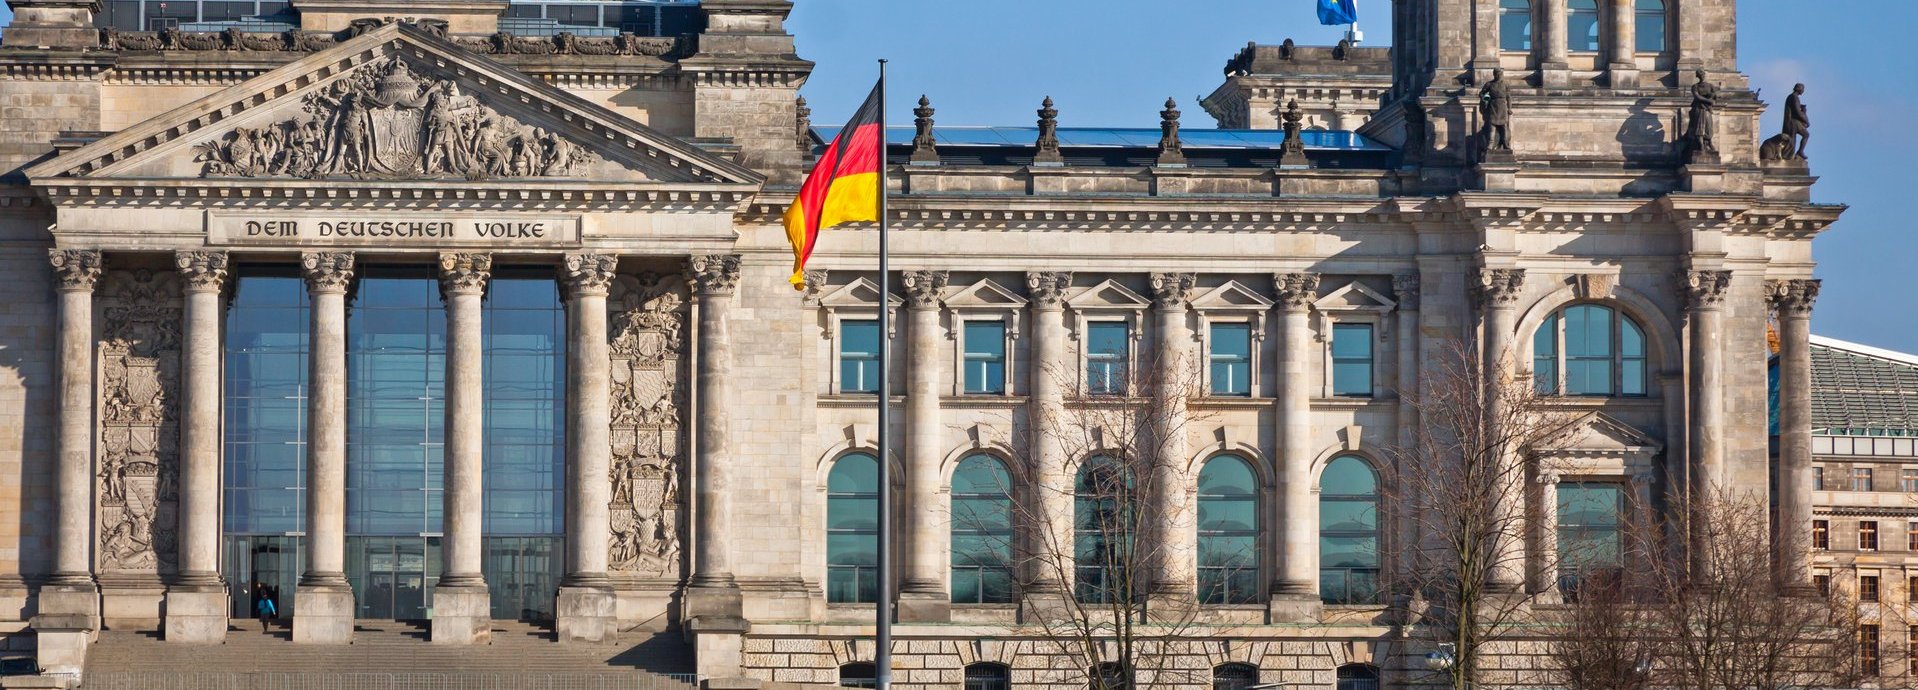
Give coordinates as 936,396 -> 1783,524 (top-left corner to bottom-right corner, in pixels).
0,0 -> 1843,688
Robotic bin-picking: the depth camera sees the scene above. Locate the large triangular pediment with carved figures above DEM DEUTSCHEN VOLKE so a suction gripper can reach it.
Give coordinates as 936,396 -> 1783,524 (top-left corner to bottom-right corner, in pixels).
27,23 -> 763,188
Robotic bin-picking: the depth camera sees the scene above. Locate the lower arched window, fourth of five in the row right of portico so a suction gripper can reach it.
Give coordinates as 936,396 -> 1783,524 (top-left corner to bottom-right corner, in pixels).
1199,454 -> 1260,604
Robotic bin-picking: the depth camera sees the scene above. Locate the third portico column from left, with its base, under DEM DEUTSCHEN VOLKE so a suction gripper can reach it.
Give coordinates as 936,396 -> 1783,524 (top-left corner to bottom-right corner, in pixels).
293,251 -> 355,644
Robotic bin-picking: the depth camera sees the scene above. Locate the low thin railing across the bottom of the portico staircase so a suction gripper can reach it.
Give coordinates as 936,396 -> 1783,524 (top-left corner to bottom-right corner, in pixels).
81,671 -> 698,690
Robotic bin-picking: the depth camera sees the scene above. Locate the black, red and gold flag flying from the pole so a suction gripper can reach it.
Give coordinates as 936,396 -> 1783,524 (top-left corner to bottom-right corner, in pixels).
786,86 -> 886,289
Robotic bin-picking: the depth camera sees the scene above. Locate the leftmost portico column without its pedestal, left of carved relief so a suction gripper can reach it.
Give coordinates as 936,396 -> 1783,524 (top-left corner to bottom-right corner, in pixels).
50,249 -> 104,587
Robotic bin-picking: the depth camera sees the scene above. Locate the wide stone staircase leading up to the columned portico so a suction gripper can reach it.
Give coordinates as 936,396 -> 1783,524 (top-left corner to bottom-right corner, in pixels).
81,621 -> 694,690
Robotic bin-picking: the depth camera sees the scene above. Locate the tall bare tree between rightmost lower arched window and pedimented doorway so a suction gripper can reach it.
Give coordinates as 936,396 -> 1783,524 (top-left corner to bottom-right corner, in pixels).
1387,343 -> 1580,690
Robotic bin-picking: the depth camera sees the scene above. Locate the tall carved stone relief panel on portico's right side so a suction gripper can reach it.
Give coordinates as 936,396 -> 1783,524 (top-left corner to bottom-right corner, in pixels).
606,272 -> 687,579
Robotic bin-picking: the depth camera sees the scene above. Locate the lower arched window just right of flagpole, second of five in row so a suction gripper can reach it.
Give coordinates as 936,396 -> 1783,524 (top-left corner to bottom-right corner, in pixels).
951,454 -> 1013,604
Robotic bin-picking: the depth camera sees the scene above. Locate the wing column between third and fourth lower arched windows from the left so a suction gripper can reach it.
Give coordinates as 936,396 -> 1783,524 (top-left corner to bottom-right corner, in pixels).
1147,272 -> 1199,605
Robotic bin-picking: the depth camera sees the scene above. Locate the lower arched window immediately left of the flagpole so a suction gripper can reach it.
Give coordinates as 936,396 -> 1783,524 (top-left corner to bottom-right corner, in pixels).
827,452 -> 878,604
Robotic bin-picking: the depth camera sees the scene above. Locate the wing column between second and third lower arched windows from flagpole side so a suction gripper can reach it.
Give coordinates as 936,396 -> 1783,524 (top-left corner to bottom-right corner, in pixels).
1015,272 -> 1078,613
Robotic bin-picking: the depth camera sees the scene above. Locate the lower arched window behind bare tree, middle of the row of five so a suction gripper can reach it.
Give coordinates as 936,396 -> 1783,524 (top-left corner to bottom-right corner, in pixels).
1072,456 -> 1135,604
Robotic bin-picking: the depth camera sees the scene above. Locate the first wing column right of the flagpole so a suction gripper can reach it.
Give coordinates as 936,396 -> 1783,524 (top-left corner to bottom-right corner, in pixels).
898,270 -> 951,623
